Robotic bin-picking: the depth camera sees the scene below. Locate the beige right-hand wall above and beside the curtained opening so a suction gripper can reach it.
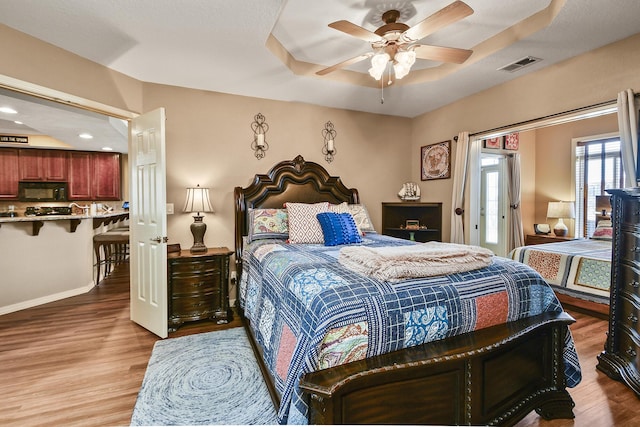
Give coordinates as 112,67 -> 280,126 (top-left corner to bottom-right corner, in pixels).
410,33 -> 640,241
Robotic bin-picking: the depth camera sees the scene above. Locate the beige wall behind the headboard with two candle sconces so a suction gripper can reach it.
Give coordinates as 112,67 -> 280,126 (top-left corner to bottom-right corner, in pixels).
144,84 -> 417,252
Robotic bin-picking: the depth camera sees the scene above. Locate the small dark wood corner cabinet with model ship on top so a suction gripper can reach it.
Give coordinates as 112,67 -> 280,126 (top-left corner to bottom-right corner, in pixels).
382,202 -> 442,242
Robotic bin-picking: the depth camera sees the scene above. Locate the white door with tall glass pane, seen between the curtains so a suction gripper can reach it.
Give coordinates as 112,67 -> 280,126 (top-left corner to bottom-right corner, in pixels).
480,154 -> 507,256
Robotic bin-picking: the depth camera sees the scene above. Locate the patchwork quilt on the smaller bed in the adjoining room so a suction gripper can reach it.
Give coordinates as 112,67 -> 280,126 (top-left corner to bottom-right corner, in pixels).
509,239 -> 611,304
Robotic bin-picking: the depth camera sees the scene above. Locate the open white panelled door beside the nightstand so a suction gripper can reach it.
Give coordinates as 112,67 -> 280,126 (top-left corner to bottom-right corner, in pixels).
129,108 -> 168,338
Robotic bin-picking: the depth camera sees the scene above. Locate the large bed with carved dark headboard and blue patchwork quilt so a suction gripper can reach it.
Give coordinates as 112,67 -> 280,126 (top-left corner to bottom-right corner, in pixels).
234,156 -> 581,425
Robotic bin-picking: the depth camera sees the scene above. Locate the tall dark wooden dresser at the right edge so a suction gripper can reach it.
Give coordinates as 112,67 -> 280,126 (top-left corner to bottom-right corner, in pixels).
597,189 -> 640,397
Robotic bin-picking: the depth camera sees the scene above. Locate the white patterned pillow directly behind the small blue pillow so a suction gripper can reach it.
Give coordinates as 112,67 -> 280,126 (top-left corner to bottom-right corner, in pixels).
285,202 -> 329,244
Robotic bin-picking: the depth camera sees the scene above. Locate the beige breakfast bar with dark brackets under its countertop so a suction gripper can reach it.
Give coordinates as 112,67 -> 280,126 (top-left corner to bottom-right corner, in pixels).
0,211 -> 129,315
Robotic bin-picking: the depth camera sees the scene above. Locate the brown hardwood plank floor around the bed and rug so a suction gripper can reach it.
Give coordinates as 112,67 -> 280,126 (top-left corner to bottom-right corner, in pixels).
0,267 -> 640,427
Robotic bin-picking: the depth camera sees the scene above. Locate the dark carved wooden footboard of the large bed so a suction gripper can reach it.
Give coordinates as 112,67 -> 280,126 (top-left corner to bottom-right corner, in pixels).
301,313 -> 574,425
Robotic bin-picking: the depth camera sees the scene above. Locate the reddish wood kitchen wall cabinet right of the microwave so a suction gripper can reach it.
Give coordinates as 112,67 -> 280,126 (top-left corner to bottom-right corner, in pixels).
69,151 -> 121,200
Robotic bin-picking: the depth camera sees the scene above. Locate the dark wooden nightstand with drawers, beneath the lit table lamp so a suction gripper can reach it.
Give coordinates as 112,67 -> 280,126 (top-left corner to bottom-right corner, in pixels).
167,247 -> 233,332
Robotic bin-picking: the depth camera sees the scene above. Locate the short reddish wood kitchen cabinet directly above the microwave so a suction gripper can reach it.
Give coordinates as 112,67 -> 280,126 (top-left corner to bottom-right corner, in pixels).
19,149 -> 67,182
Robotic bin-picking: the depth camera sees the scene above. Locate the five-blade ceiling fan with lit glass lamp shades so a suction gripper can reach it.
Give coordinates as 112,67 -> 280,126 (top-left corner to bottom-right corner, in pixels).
316,1 -> 473,80
